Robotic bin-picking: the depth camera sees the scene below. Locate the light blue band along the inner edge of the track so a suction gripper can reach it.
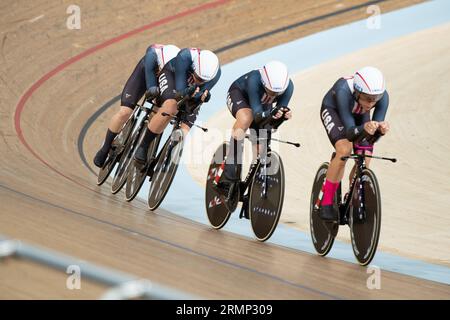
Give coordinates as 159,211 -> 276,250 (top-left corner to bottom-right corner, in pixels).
138,0 -> 450,284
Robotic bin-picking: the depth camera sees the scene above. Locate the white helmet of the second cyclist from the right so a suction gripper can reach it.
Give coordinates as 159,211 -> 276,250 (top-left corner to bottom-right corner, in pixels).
259,61 -> 289,95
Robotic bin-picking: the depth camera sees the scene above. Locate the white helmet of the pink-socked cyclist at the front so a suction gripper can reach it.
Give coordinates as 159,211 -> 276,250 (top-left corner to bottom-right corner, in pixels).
353,67 -> 386,101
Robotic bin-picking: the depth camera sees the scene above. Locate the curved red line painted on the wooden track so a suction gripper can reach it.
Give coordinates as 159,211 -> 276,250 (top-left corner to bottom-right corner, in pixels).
14,0 -> 230,186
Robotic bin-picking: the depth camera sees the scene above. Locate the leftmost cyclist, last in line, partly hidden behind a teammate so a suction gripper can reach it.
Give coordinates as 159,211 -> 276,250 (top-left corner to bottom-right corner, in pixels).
94,44 -> 180,168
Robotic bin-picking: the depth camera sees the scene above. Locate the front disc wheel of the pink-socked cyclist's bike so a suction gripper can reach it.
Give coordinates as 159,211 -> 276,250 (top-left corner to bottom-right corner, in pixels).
349,169 -> 381,266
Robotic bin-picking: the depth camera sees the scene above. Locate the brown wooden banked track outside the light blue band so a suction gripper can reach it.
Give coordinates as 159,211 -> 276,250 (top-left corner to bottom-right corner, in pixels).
0,0 -> 450,299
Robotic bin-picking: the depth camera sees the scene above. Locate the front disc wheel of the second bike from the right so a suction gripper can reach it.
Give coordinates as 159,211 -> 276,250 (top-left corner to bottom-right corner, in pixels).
249,152 -> 284,241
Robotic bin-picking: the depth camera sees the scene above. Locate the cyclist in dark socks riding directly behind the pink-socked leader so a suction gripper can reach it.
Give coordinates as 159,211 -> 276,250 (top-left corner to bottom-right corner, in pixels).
221,61 -> 294,184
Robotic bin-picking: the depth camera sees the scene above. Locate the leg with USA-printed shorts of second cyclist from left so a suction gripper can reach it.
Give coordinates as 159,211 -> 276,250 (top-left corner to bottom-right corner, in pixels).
134,65 -> 178,163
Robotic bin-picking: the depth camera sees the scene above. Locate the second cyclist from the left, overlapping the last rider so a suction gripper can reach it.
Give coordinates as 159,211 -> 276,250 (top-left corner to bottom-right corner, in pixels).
134,48 -> 221,163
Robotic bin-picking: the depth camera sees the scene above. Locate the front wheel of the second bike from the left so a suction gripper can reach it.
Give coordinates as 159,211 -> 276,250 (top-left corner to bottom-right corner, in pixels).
148,129 -> 184,211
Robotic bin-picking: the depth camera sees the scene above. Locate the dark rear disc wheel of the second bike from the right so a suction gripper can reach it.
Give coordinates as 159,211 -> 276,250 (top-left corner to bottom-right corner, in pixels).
205,143 -> 231,229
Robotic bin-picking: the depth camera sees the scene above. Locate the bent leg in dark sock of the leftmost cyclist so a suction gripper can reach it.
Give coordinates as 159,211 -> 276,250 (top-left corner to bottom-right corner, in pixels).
94,59 -> 145,167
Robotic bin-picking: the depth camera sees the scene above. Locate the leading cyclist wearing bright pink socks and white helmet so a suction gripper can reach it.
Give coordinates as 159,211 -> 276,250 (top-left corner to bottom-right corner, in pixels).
319,67 -> 389,221
